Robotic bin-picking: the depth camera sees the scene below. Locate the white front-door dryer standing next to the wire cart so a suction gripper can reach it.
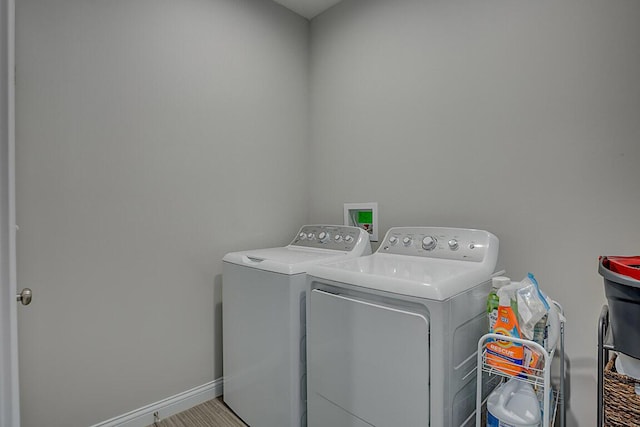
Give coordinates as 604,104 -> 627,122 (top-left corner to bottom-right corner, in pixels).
307,227 -> 498,427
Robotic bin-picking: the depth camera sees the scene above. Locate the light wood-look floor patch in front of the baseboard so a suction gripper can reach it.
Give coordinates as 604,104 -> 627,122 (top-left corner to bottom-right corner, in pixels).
149,397 -> 246,427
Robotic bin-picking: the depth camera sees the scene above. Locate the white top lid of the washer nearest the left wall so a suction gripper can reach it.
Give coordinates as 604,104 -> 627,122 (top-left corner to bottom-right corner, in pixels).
222,246 -> 355,274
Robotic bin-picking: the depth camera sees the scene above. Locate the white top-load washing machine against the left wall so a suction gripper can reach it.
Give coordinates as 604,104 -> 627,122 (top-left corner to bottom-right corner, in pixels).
222,225 -> 371,427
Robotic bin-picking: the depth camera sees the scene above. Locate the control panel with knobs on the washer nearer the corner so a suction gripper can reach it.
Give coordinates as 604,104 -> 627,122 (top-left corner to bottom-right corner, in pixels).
291,225 -> 368,252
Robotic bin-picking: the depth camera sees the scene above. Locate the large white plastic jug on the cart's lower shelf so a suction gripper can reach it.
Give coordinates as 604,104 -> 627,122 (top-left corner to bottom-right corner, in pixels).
487,378 -> 541,427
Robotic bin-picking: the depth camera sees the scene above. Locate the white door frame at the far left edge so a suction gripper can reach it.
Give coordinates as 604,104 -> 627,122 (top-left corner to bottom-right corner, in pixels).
0,0 -> 20,427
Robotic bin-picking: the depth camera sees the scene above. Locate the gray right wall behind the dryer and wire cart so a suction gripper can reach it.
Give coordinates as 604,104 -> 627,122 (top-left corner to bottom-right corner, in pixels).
311,0 -> 640,425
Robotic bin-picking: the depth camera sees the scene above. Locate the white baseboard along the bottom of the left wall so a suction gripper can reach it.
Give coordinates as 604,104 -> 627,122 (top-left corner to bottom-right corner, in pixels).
91,378 -> 222,427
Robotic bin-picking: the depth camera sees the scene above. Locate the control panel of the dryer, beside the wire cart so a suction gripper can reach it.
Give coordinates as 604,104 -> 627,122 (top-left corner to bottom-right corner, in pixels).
378,227 -> 498,262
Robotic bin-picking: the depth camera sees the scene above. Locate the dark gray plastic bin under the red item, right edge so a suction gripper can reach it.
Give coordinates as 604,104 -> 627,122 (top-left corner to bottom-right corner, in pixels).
598,257 -> 640,359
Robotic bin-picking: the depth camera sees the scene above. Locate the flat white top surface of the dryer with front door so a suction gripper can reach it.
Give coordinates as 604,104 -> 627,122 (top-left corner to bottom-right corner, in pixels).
307,252 -> 495,301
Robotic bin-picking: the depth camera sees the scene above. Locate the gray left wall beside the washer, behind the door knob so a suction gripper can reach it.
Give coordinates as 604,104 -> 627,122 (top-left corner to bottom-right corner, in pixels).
17,0 -> 309,427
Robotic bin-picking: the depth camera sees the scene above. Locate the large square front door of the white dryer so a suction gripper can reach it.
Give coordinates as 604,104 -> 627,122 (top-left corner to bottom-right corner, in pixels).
307,289 -> 429,427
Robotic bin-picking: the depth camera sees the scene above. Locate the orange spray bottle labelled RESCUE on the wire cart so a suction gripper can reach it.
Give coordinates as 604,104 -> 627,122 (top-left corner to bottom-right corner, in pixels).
487,285 -> 524,375
